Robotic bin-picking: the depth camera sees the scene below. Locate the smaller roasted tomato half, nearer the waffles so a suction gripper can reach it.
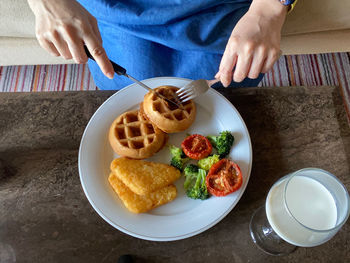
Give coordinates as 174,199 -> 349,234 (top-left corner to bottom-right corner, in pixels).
181,134 -> 213,160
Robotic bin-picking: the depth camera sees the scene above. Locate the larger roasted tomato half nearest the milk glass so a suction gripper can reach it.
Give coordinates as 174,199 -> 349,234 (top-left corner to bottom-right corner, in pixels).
205,159 -> 243,196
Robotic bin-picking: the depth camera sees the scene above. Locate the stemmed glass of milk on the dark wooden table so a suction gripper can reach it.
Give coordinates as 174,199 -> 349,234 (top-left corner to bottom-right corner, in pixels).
249,168 -> 350,255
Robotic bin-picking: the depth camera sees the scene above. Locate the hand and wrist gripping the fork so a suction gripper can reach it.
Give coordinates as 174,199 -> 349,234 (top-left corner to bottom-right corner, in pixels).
215,0 -> 287,87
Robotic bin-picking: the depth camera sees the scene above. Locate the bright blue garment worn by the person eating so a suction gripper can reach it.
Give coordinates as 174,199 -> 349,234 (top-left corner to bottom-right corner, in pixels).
79,0 -> 258,89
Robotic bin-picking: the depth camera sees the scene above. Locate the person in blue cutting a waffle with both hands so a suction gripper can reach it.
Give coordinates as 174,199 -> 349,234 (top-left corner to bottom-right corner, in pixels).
28,0 -> 288,89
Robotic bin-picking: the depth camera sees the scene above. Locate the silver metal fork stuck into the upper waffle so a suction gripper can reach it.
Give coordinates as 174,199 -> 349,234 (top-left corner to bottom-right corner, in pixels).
176,79 -> 219,103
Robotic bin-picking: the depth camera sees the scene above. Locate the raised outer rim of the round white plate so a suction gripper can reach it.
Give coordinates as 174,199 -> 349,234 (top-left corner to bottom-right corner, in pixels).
78,77 -> 253,242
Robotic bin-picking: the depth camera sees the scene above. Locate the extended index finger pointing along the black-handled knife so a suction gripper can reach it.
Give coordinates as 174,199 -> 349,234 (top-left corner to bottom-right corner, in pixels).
84,34 -> 114,79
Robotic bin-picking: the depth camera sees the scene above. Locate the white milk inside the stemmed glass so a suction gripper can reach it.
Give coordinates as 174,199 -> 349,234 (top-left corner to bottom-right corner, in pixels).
266,176 -> 337,247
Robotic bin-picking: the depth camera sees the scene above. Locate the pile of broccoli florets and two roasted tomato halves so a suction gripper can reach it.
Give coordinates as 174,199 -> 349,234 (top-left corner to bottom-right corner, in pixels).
169,131 -> 239,200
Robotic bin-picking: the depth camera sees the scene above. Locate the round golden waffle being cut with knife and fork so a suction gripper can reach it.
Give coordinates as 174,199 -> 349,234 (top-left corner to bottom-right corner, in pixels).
141,86 -> 196,133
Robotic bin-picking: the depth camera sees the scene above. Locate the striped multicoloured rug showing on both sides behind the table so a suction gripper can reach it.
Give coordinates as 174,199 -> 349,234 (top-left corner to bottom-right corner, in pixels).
0,53 -> 350,116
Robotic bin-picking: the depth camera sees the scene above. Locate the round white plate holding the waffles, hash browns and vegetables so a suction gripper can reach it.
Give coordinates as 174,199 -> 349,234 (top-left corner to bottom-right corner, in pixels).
79,77 -> 252,241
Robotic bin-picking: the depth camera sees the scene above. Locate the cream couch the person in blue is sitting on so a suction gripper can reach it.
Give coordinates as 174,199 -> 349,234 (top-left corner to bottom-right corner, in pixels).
0,0 -> 350,65
